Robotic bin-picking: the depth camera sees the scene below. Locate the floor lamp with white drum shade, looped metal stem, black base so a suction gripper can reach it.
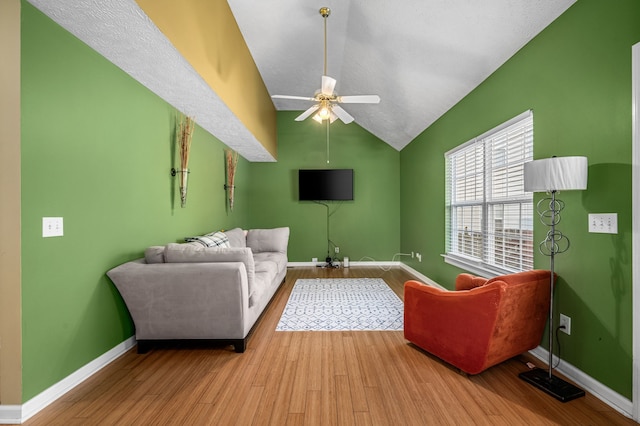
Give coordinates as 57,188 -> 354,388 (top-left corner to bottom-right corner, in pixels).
520,157 -> 587,402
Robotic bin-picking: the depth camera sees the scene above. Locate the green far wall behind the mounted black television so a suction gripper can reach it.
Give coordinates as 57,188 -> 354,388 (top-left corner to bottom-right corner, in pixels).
248,111 -> 400,262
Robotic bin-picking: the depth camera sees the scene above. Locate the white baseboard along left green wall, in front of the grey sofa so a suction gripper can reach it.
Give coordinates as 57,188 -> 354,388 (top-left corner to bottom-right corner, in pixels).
0,337 -> 136,424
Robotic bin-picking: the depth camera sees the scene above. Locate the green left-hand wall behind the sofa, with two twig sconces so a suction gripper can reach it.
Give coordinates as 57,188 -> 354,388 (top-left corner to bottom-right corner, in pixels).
21,2 -> 248,401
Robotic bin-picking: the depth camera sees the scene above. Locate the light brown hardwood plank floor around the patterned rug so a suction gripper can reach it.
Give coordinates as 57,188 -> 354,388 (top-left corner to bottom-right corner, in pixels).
18,267 -> 636,425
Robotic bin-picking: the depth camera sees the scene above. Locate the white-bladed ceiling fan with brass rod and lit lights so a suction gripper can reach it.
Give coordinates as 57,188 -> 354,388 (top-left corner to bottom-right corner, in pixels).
271,7 -> 380,124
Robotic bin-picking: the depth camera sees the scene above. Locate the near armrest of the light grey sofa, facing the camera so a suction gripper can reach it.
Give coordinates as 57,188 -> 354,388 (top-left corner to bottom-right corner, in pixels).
107,260 -> 250,340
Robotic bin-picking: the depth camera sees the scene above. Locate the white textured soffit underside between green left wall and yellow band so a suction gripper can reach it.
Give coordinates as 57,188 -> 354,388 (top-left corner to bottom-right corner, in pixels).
28,0 -> 275,161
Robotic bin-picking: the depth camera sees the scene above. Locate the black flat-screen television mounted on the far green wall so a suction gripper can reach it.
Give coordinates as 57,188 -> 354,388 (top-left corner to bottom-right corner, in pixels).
298,169 -> 353,201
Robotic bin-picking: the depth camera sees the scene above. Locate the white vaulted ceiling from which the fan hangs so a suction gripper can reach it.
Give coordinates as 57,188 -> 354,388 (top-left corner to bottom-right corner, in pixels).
228,0 -> 575,150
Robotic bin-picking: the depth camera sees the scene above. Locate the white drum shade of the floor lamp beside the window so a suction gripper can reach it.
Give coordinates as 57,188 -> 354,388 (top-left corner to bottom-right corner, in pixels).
524,157 -> 588,192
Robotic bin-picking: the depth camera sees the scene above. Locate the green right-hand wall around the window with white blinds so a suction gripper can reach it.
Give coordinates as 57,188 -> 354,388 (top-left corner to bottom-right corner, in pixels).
400,0 -> 640,398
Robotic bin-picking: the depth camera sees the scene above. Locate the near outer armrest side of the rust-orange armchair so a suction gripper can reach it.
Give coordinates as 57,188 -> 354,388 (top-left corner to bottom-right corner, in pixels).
404,281 -> 505,374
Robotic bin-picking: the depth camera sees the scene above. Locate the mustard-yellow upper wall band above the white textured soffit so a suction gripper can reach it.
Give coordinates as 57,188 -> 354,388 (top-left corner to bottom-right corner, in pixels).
137,0 -> 277,158
